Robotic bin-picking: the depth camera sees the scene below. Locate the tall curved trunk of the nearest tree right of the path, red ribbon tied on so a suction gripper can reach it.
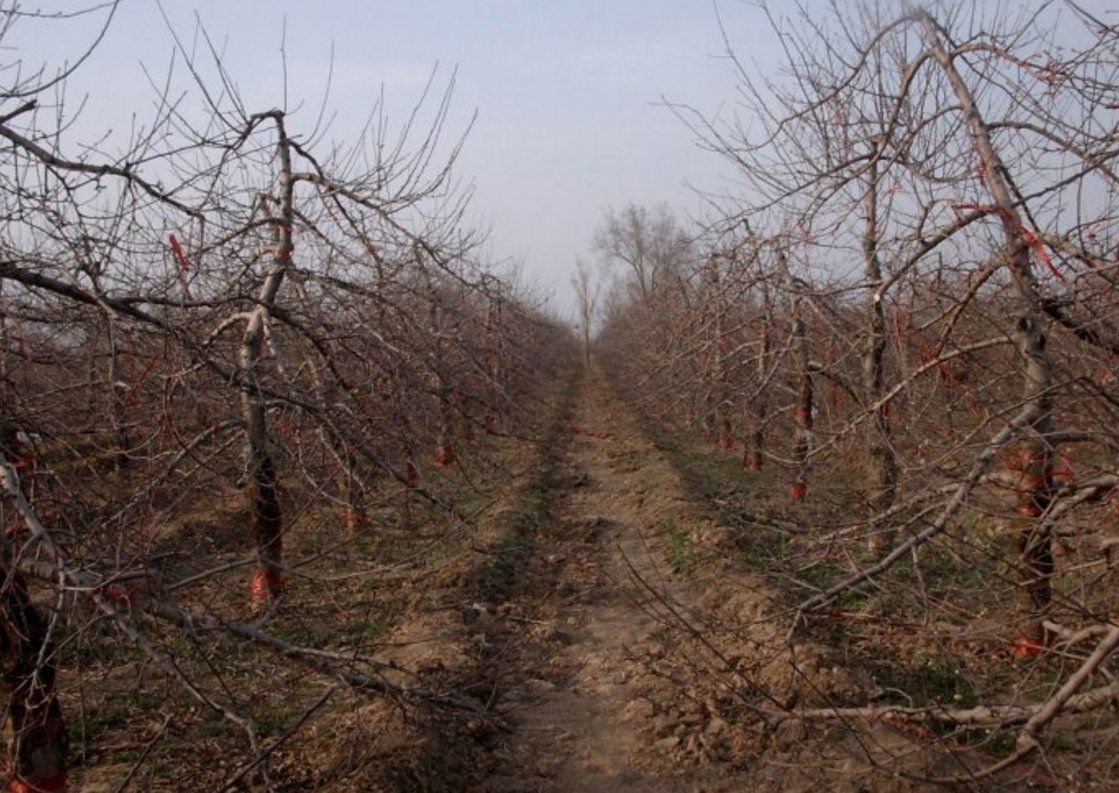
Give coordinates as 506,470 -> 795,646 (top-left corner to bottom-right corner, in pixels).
918,11 -> 1054,655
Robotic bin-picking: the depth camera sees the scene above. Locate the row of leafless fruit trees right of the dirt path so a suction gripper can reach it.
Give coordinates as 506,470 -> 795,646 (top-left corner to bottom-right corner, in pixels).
599,1 -> 1119,778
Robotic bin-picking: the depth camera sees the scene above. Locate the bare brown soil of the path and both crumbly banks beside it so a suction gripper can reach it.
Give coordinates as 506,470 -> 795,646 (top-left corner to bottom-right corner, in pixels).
65,371 -> 1078,793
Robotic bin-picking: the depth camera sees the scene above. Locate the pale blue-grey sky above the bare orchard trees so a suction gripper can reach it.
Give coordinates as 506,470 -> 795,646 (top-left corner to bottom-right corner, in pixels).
10,0 -> 781,317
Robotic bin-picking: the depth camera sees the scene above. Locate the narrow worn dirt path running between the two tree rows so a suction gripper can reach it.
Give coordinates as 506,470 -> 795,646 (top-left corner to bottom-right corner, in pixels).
476,376 -> 747,793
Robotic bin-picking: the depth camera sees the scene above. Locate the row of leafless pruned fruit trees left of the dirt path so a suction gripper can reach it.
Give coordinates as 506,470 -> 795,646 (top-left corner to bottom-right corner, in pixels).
0,3 -> 559,790
